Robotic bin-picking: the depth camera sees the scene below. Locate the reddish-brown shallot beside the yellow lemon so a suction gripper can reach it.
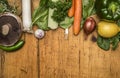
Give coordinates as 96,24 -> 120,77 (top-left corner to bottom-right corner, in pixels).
83,17 -> 96,35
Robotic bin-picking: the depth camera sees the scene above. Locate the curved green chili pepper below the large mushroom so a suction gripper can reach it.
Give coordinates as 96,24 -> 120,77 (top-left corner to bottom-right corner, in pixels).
0,40 -> 25,52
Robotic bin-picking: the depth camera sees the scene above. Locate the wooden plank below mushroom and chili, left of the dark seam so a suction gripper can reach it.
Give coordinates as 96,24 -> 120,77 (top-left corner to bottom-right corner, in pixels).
0,0 -> 38,78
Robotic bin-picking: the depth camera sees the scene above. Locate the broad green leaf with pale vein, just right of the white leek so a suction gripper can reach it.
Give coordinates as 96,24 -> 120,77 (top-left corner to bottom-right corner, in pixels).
32,0 -> 49,30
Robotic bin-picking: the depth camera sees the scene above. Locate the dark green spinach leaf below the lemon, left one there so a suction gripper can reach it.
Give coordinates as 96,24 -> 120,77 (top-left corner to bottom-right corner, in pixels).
97,35 -> 110,51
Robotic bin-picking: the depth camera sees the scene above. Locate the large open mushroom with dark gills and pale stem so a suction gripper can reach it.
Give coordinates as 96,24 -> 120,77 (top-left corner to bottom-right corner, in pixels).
0,12 -> 22,46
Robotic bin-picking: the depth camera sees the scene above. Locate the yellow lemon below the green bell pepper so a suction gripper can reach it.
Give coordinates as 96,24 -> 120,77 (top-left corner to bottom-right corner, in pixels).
98,21 -> 120,38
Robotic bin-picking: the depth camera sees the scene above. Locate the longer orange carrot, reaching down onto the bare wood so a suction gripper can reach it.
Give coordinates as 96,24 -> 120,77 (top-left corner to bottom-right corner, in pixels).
73,0 -> 82,35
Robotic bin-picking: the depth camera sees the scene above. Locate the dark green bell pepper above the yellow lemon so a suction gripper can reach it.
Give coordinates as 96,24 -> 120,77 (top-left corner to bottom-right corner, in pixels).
95,0 -> 120,21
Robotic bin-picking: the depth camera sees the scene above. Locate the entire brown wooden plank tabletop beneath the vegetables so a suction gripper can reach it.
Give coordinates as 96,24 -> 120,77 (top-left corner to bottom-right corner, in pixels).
0,0 -> 120,78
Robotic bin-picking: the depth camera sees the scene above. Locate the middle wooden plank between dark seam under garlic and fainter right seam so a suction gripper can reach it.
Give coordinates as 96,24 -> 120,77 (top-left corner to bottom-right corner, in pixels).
39,29 -> 82,78
